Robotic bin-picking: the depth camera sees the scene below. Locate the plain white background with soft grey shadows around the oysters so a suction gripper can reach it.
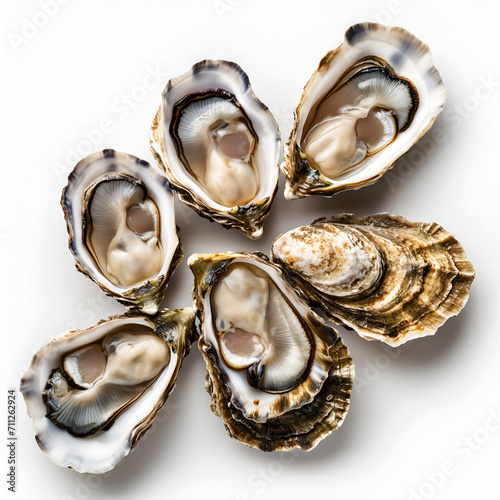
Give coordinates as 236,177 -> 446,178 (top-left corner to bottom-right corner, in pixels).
0,0 -> 500,500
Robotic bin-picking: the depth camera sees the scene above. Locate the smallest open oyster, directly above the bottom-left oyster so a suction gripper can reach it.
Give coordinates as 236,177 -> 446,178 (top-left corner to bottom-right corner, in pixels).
61,149 -> 183,314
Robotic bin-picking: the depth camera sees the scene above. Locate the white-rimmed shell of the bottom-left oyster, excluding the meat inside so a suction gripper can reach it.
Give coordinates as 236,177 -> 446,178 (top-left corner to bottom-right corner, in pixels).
20,308 -> 195,474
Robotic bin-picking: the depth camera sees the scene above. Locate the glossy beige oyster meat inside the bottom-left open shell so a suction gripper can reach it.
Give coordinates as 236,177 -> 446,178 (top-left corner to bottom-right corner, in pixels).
43,326 -> 170,437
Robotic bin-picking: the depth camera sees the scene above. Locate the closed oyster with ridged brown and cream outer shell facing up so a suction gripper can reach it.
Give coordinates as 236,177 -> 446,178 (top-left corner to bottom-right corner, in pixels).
271,214 -> 474,346
